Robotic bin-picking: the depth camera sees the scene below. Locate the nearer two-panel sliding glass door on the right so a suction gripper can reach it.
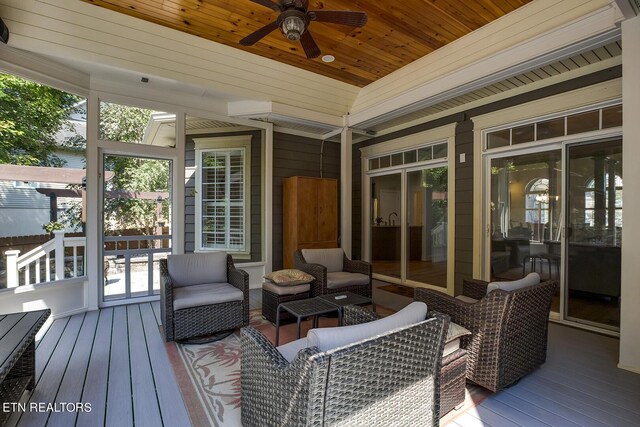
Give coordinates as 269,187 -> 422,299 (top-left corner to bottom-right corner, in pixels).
486,139 -> 623,330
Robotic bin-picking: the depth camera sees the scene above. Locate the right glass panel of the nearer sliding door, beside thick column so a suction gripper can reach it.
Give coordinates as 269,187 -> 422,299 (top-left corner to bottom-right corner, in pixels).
566,140 -> 622,329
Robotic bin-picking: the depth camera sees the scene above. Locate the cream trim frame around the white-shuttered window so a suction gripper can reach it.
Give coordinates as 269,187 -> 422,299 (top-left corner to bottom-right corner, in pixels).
193,135 -> 251,259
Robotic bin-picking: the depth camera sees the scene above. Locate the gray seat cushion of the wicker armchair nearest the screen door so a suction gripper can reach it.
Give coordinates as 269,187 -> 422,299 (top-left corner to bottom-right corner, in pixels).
173,283 -> 244,311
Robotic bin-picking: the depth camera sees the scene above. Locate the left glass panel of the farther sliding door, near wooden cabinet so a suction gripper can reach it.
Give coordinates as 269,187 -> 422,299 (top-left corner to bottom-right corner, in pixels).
371,173 -> 402,279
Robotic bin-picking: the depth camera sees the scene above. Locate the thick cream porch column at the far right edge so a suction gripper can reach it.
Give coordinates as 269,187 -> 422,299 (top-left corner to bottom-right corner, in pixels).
618,16 -> 640,373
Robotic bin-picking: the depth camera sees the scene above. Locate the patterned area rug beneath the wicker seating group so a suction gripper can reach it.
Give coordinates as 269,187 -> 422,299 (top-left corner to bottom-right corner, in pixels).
167,310 -> 490,427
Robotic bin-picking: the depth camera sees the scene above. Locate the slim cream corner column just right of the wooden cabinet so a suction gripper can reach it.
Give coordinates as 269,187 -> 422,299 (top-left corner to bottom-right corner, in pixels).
340,127 -> 353,258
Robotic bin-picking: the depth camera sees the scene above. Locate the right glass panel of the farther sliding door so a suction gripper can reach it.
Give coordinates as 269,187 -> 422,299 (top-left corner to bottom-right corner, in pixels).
406,167 -> 448,288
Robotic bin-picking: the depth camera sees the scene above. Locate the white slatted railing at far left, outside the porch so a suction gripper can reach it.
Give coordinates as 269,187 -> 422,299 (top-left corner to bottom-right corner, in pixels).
5,230 -> 86,288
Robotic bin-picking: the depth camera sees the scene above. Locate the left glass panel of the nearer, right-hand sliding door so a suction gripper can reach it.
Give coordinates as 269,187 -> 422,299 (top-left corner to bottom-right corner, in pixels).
490,150 -> 562,312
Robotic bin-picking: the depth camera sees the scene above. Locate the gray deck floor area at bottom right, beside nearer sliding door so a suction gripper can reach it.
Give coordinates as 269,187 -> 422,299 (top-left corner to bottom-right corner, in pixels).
448,323 -> 640,427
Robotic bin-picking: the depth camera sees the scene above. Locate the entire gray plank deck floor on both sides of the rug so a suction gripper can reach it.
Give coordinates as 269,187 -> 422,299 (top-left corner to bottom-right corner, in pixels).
7,291 -> 640,427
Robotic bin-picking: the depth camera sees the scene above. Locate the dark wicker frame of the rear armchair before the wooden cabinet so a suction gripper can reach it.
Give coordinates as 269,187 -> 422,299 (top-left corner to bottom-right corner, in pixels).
293,250 -> 371,298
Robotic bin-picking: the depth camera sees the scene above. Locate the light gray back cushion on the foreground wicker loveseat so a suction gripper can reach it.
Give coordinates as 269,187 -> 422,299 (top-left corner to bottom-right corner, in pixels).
307,301 -> 427,351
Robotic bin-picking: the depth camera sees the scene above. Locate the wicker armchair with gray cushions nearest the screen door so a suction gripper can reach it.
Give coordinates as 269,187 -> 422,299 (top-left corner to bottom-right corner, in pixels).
160,252 -> 249,341
